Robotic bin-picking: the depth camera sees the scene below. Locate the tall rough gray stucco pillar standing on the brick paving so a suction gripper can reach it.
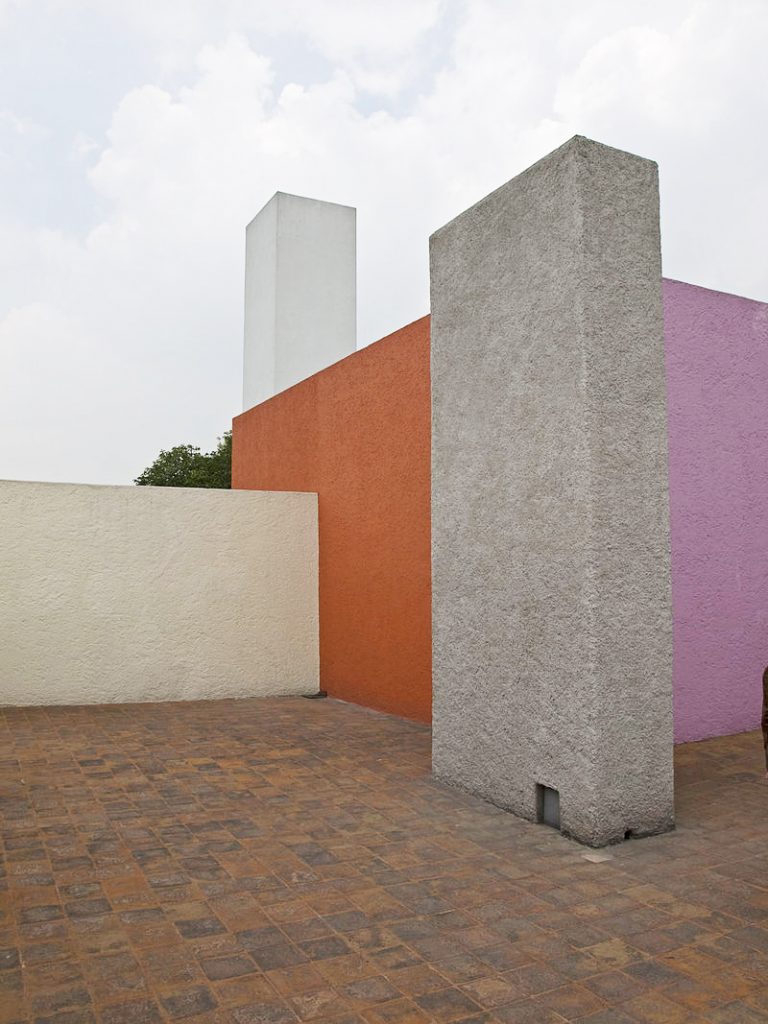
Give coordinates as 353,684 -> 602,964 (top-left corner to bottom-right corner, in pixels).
430,137 -> 673,846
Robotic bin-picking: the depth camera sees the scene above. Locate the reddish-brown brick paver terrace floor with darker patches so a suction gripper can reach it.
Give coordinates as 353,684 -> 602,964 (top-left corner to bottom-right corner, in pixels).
0,698 -> 768,1024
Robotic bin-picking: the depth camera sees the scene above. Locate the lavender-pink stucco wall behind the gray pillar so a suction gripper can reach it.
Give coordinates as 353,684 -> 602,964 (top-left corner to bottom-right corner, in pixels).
664,281 -> 768,742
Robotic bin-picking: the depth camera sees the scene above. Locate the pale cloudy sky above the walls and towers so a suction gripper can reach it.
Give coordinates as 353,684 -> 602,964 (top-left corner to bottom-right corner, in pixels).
0,0 -> 768,483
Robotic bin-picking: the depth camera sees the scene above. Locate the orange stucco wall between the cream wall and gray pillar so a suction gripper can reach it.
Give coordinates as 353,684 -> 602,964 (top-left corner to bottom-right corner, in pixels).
232,316 -> 432,722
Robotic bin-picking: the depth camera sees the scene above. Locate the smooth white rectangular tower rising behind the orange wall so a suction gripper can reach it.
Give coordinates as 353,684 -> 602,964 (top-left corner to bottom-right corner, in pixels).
243,193 -> 356,409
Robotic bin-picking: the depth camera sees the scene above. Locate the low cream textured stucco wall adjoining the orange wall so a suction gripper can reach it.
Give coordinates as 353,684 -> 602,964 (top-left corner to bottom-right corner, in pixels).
0,481 -> 318,705
